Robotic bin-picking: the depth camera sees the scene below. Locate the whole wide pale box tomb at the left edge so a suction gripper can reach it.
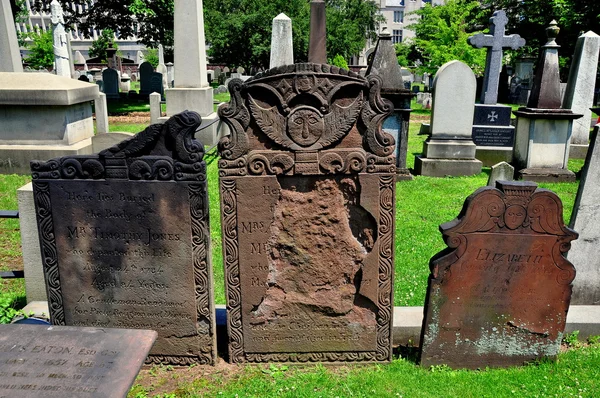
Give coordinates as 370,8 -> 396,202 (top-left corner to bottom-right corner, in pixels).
0,73 -> 98,174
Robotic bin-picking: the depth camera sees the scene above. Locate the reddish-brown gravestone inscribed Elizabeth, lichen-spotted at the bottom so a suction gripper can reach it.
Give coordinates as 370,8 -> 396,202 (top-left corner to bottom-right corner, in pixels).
421,181 -> 577,369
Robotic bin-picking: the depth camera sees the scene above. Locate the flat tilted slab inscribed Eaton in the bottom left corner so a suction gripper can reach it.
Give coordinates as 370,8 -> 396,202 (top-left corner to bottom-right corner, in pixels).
0,325 -> 156,398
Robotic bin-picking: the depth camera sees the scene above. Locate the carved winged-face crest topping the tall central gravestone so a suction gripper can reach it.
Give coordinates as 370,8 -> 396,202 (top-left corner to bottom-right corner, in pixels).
218,64 -> 395,176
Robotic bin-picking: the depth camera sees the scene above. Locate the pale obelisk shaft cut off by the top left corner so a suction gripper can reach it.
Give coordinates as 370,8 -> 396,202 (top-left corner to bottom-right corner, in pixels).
0,0 -> 23,72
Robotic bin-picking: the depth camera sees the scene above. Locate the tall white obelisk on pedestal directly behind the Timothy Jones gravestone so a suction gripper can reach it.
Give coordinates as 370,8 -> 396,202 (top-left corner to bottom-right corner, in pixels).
160,0 -> 219,145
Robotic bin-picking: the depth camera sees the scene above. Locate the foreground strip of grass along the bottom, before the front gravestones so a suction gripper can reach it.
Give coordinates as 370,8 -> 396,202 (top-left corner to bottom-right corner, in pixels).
128,344 -> 600,398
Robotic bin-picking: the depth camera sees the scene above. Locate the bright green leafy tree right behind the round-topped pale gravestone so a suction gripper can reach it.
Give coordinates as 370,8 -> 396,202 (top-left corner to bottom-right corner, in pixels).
407,0 -> 486,75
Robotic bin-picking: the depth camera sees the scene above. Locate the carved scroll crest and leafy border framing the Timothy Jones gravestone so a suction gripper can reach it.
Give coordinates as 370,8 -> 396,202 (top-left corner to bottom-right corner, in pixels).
31,111 -> 216,366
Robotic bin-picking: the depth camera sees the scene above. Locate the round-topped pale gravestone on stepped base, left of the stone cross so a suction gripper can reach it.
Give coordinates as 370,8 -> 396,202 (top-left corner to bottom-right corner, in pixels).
415,61 -> 481,177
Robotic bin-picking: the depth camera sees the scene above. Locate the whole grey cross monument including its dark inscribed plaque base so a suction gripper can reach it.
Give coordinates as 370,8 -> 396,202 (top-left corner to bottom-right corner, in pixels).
469,10 -> 525,166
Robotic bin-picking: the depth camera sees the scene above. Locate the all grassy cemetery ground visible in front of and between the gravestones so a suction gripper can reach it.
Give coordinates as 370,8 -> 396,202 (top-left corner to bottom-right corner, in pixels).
0,102 -> 600,397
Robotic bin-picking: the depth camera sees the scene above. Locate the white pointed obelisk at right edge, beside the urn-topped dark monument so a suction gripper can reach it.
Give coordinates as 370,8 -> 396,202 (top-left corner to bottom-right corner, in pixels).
563,31 -> 600,159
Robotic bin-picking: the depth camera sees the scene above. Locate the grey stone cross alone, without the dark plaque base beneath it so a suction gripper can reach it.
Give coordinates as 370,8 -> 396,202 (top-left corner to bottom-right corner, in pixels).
469,10 -> 525,104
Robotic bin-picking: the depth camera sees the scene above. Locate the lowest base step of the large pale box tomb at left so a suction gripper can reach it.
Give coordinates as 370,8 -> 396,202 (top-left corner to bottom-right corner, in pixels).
0,138 -> 92,174
